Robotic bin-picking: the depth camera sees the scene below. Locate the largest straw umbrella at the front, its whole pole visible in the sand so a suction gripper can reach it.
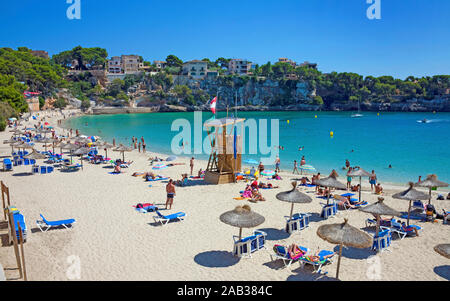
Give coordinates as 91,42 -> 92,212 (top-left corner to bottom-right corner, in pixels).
317,219 -> 373,278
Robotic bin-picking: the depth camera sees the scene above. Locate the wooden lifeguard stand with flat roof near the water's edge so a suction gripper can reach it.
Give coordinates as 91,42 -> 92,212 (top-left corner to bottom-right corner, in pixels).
205,118 -> 245,184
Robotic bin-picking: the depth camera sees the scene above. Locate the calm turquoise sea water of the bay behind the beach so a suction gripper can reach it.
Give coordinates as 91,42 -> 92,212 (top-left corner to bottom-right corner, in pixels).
65,112 -> 450,184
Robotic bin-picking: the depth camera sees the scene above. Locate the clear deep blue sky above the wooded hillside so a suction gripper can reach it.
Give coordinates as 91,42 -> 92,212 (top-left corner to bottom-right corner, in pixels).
0,0 -> 450,78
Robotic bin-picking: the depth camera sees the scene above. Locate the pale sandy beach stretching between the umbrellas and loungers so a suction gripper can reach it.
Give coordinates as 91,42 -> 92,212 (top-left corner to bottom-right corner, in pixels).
0,109 -> 450,281
